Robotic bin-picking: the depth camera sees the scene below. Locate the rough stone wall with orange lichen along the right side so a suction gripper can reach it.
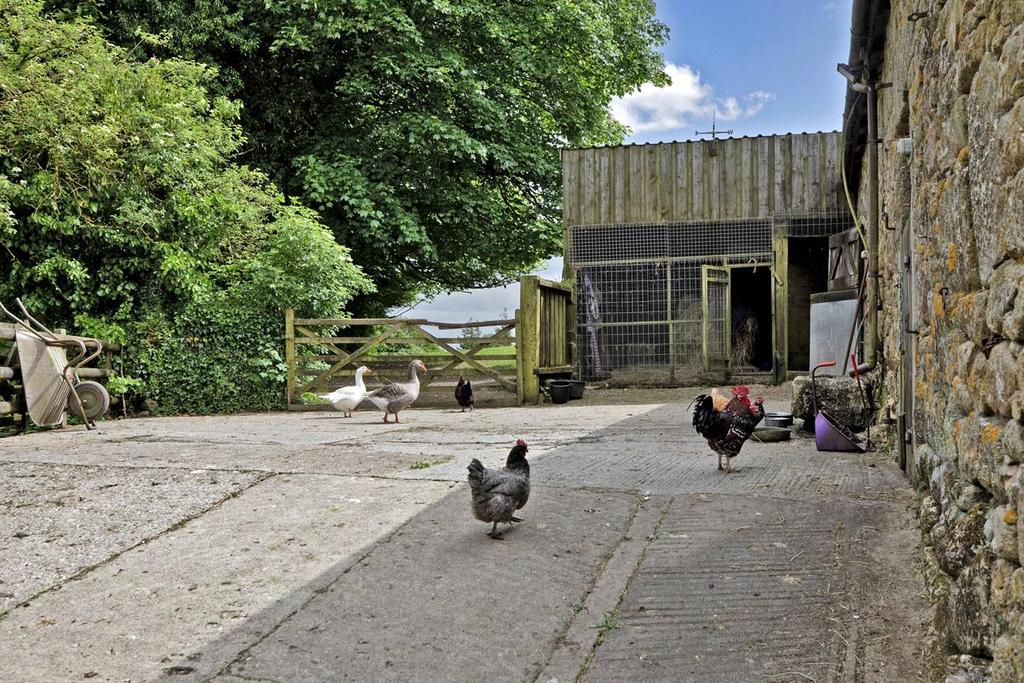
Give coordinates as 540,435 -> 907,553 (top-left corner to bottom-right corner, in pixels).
860,0 -> 1024,681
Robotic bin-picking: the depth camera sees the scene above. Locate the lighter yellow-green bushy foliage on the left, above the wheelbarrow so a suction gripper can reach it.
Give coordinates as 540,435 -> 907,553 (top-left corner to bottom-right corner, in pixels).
0,0 -> 372,413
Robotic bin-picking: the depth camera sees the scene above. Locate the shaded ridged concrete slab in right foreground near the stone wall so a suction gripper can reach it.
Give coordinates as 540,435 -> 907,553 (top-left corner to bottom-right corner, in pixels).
583,495 -> 883,682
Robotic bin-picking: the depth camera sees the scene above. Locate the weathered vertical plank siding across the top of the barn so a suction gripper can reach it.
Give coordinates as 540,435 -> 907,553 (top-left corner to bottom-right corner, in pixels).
562,132 -> 842,227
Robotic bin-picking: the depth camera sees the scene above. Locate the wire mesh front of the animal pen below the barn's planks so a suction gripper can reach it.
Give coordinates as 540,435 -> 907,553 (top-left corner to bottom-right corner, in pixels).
566,213 -> 850,385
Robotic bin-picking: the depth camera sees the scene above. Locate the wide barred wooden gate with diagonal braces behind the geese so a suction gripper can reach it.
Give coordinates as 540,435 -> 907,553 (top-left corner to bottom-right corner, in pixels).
285,309 -> 517,410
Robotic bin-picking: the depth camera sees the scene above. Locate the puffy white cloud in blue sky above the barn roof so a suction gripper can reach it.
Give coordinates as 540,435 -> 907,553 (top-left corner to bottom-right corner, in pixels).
611,62 -> 774,133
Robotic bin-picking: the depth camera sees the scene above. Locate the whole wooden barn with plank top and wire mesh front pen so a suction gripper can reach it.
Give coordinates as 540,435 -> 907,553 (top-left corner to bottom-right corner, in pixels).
562,132 -> 852,385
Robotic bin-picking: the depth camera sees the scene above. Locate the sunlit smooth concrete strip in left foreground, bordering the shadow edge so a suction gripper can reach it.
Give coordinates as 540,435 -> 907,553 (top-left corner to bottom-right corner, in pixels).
0,475 -> 449,681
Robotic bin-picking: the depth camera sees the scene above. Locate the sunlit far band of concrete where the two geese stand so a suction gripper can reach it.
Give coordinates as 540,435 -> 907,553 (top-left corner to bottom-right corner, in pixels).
0,405 -> 638,479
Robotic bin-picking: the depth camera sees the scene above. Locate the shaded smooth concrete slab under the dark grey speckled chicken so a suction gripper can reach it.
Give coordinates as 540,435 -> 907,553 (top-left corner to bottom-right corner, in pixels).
225,485 -> 638,682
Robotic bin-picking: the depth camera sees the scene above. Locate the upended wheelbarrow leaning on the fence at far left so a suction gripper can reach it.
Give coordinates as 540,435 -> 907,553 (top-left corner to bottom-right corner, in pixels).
0,299 -> 111,429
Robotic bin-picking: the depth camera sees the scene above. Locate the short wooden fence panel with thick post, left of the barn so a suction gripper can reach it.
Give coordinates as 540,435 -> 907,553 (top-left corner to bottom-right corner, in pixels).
516,275 -> 575,403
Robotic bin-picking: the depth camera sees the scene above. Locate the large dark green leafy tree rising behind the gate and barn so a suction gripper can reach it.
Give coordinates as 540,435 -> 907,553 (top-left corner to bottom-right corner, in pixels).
51,0 -> 667,313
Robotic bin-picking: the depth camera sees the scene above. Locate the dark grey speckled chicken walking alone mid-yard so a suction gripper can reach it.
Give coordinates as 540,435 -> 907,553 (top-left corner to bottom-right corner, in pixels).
467,439 -> 529,539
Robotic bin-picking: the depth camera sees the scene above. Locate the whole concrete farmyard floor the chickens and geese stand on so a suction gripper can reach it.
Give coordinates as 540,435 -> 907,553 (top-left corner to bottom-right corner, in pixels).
0,390 -> 927,683
